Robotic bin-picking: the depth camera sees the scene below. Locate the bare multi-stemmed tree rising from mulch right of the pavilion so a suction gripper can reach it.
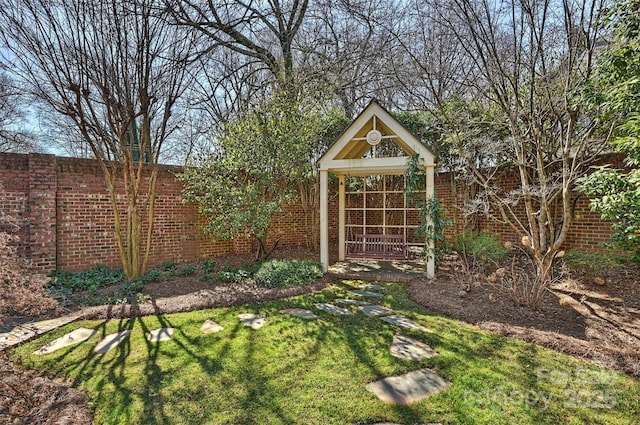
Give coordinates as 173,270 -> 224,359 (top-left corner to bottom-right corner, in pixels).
398,0 -> 607,304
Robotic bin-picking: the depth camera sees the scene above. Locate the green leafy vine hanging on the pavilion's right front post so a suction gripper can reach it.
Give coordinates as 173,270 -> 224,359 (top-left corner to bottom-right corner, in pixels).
404,154 -> 451,271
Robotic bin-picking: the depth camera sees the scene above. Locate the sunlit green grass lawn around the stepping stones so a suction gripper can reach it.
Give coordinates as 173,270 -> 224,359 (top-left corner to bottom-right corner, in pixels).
12,281 -> 640,425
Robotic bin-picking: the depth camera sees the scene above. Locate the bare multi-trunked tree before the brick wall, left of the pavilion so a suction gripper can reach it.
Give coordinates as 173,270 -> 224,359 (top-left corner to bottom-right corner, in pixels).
0,0 -> 193,278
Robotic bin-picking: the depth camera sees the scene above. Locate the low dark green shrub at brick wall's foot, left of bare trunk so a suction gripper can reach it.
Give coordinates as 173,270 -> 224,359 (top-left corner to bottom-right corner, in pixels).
49,265 -> 125,294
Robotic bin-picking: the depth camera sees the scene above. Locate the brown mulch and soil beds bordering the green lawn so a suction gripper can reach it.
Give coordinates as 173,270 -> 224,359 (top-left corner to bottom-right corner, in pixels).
0,251 -> 640,425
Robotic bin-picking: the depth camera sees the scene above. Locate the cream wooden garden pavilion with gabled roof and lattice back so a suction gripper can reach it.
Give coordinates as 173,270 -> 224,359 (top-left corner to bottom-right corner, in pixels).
319,100 -> 436,277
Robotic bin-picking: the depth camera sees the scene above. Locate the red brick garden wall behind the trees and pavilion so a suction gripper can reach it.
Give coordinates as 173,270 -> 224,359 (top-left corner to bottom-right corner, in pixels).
0,154 -> 611,271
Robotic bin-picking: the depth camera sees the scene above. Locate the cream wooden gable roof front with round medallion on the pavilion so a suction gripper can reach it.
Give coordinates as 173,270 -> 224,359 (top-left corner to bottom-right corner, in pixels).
318,100 -> 435,175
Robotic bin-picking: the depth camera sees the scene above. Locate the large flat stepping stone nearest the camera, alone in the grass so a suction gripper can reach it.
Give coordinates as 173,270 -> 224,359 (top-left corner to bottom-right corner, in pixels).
367,368 -> 451,406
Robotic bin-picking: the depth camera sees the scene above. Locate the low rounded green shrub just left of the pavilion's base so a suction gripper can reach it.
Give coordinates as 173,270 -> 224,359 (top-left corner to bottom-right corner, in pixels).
254,260 -> 322,288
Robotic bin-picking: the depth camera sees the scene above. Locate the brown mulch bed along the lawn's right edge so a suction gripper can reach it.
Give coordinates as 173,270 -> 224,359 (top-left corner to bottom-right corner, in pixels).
408,265 -> 640,377
